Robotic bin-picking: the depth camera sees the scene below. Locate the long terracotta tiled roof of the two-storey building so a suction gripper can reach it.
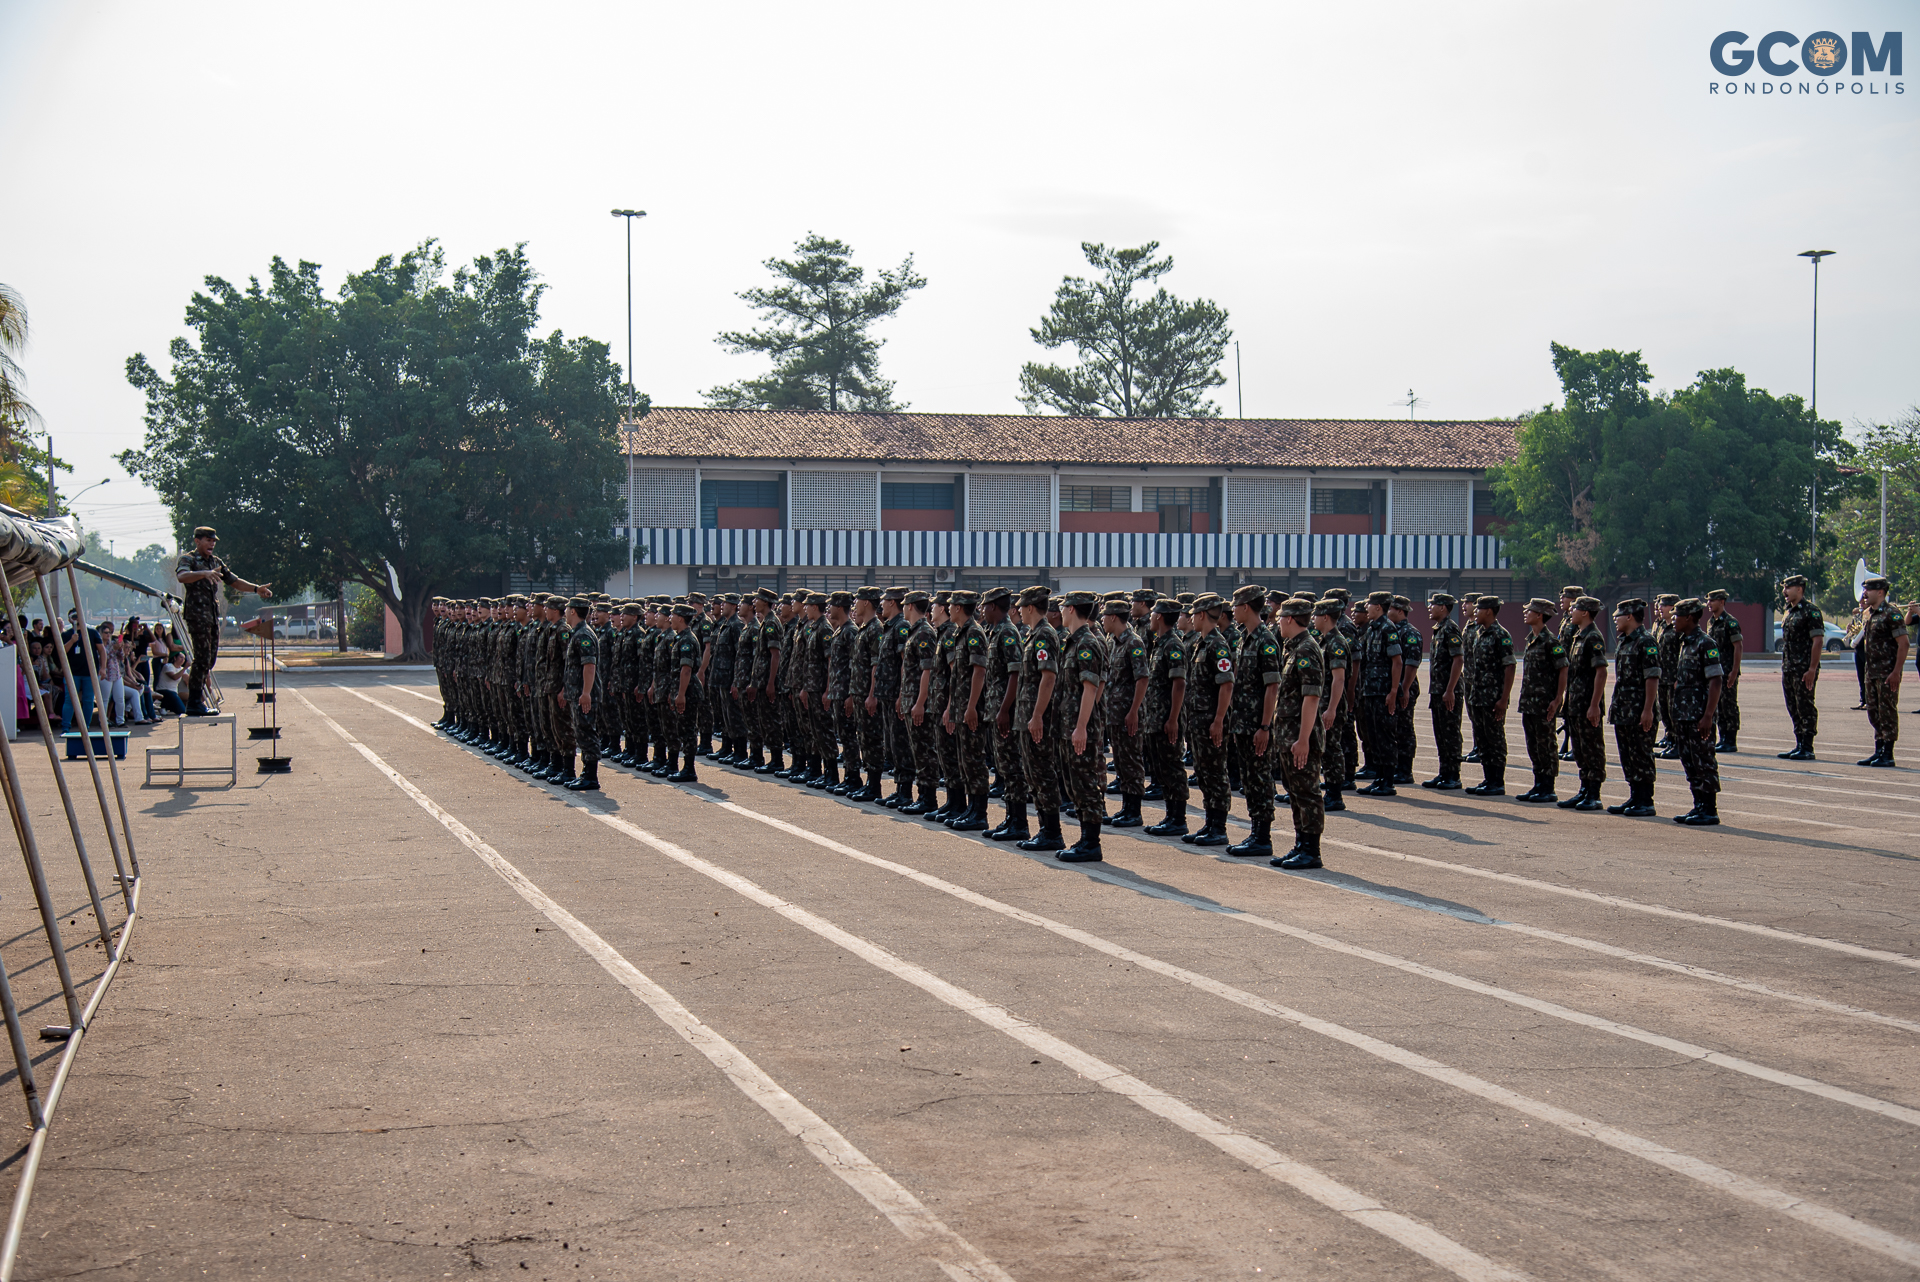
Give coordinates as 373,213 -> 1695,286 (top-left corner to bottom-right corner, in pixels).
630,407 -> 1519,468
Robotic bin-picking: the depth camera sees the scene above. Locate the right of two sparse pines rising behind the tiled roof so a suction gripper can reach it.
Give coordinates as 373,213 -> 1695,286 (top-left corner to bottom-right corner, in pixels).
1020,240 -> 1233,418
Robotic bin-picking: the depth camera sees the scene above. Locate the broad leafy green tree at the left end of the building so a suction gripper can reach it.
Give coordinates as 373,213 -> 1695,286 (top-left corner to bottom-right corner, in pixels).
121,242 -> 624,656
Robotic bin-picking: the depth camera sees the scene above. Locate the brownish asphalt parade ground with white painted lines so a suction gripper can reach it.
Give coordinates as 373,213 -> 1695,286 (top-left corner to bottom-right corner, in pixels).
0,670 -> 1920,1282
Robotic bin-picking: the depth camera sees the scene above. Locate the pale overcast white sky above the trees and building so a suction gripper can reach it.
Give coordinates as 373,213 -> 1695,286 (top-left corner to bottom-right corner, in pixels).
0,0 -> 1920,555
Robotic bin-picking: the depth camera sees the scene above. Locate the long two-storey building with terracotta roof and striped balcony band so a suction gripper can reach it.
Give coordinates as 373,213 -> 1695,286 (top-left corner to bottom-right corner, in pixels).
609,409 -> 1519,610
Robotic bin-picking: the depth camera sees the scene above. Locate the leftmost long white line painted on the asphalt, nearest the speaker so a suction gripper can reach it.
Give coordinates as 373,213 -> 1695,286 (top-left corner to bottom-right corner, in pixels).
294,691 -> 1012,1282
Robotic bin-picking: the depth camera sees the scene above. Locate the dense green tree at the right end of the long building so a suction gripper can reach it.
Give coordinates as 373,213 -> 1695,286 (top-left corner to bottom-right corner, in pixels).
1492,344 -> 1843,601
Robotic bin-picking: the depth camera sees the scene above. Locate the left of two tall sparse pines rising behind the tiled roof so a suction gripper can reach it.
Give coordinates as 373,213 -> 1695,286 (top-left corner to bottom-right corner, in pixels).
705,232 -> 927,415
